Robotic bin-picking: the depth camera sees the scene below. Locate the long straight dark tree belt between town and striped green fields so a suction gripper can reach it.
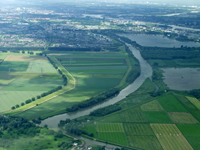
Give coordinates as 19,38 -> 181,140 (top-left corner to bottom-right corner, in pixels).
48,47 -> 101,52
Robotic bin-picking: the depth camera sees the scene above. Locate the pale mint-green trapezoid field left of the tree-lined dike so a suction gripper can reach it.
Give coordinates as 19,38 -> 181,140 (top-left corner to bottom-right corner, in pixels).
26,61 -> 57,73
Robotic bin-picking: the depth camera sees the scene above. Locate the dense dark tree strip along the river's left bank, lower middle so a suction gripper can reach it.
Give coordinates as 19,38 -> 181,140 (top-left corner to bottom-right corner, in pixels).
66,88 -> 119,112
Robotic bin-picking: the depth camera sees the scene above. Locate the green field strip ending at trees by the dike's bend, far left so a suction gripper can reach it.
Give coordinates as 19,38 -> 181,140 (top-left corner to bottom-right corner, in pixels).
3,78 -> 63,91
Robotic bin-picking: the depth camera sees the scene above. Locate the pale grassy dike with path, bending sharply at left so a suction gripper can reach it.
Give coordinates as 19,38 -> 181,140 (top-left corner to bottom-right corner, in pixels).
0,57 -> 76,115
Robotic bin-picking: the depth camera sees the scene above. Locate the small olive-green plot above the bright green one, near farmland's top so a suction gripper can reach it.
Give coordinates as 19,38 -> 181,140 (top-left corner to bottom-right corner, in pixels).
140,100 -> 163,111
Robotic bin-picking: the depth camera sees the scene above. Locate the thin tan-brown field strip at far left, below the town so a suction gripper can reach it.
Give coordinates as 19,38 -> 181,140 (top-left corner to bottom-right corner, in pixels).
4,55 -> 48,61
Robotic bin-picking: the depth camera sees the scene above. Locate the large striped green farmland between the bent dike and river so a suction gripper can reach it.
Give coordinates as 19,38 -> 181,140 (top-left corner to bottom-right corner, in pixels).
14,52 -> 130,119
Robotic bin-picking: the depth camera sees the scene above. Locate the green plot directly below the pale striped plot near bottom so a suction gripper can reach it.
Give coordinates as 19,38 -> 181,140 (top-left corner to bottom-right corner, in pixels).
98,132 -> 129,146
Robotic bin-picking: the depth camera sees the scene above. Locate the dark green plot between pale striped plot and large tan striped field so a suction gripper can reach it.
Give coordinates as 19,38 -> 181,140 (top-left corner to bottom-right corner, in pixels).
124,123 -> 154,136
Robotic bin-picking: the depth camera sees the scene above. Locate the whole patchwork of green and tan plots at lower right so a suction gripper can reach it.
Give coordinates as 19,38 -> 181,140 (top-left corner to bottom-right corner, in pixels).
82,93 -> 200,150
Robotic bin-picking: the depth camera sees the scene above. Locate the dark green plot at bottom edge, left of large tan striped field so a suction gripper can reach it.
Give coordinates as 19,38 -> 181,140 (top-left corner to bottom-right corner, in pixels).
127,135 -> 162,150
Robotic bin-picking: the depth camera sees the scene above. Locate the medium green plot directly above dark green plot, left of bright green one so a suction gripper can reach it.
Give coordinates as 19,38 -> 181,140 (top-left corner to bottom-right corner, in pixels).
120,107 -> 147,122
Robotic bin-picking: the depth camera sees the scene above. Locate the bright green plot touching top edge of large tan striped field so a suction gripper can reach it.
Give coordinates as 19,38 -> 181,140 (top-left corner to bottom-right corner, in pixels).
144,111 -> 173,123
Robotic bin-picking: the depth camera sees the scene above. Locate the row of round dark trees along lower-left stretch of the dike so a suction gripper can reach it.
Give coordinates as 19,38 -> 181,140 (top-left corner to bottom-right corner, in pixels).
11,86 -> 62,109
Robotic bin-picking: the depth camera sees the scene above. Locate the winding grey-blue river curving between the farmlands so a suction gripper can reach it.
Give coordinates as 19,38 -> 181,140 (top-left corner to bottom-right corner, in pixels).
41,44 -> 153,130
